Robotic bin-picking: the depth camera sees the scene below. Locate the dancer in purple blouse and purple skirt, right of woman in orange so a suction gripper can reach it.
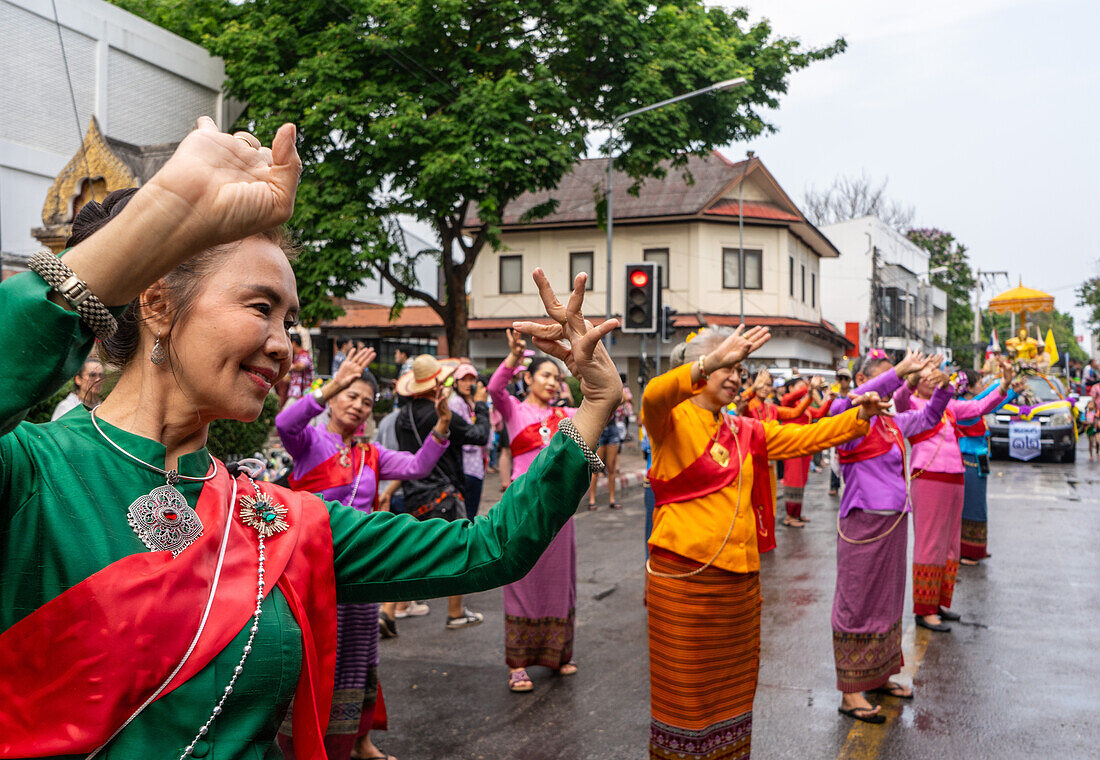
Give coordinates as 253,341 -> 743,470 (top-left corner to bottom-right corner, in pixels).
829,352 -> 952,723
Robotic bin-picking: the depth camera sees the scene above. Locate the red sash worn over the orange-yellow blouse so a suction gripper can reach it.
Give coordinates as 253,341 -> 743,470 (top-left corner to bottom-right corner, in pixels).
649,417 -> 776,553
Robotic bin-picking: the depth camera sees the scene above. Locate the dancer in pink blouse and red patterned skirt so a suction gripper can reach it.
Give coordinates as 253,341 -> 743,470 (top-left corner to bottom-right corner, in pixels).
893,364 -> 1015,632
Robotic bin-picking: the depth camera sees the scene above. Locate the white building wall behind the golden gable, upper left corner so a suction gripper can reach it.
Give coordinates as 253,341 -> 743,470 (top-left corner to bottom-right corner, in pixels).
0,0 -> 227,258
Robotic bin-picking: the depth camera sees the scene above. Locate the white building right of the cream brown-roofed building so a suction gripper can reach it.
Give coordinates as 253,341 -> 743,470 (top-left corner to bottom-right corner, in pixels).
821,217 -> 947,355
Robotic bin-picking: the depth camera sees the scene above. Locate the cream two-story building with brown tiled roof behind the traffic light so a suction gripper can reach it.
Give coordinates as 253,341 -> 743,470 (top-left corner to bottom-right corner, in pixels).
470,152 -> 849,382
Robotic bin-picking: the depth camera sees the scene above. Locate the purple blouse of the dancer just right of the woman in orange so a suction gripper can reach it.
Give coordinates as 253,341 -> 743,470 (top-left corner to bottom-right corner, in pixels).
829,370 -> 952,517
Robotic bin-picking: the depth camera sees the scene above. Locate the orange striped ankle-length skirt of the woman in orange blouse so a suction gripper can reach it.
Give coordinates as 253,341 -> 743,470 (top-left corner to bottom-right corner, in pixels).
646,552 -> 760,760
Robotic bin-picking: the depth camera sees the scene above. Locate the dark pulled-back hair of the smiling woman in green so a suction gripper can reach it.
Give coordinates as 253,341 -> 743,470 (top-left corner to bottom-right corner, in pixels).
65,187 -> 299,369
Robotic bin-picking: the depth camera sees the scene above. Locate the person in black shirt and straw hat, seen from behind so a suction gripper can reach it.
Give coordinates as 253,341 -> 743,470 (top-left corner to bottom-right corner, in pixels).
396,354 -> 492,629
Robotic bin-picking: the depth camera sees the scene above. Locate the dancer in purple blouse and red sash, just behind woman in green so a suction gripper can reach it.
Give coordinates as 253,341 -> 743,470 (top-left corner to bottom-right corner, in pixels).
275,348 -> 451,760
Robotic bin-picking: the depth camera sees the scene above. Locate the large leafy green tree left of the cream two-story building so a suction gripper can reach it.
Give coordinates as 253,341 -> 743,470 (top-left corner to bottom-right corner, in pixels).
107,0 -> 845,354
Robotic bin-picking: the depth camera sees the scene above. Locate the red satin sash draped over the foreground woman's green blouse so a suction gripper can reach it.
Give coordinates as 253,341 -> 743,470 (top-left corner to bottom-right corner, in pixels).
0,470 -> 337,758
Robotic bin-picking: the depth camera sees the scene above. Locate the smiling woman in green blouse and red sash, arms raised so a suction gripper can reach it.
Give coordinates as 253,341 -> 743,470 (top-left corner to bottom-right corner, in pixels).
0,118 -> 620,759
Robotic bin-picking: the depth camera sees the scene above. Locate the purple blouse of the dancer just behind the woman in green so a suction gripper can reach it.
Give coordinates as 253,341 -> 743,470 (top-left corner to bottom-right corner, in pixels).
275,394 -> 449,511
